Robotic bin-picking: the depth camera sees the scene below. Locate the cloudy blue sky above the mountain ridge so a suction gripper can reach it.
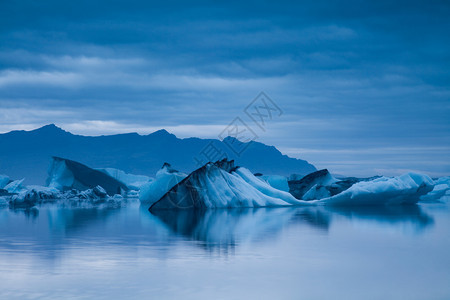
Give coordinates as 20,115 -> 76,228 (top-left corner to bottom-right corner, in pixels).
0,0 -> 450,176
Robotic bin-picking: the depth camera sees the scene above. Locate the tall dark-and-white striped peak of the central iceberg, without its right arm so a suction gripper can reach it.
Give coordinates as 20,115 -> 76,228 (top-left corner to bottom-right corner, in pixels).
150,159 -> 304,210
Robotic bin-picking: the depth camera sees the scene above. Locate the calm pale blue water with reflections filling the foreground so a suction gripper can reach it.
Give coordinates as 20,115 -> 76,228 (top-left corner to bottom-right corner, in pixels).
0,203 -> 450,299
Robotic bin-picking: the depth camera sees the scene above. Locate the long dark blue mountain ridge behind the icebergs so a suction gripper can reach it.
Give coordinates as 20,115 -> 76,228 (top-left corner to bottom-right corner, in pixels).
0,124 -> 316,184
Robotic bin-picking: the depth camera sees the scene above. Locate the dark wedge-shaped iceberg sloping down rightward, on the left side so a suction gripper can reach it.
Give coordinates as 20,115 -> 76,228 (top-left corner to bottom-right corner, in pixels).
47,156 -> 129,196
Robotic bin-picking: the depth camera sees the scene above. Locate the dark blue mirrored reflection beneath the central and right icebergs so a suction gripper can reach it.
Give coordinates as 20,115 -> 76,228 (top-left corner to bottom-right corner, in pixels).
152,205 -> 434,248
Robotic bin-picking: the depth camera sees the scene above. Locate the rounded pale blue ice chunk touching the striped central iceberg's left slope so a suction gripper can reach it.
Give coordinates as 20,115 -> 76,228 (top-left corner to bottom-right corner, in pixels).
139,163 -> 187,205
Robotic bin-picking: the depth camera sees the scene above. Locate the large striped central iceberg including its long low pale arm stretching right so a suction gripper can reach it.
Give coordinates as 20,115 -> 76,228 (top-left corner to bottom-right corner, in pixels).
149,160 -> 434,211
